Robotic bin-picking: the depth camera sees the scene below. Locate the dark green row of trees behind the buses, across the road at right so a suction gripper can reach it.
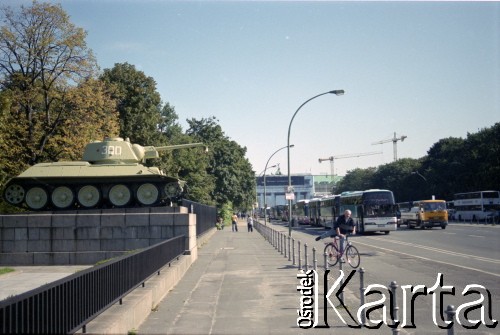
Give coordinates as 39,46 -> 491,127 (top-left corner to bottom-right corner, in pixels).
337,123 -> 500,202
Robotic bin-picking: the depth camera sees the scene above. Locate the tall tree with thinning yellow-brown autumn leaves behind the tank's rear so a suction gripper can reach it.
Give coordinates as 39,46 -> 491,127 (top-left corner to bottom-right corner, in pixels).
0,1 -> 118,212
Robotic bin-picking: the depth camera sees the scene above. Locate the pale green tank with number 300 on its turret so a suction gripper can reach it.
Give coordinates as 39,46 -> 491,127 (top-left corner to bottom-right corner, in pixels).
3,137 -> 207,211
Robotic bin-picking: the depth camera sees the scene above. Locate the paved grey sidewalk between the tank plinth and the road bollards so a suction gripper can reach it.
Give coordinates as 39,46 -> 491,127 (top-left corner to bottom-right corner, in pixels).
138,222 -> 352,334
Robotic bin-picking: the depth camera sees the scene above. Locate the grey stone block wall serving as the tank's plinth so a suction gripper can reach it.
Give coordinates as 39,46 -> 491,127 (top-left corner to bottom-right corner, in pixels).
0,207 -> 197,265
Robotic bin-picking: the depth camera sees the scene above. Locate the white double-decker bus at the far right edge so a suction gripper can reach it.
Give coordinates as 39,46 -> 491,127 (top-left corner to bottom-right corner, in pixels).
453,191 -> 500,221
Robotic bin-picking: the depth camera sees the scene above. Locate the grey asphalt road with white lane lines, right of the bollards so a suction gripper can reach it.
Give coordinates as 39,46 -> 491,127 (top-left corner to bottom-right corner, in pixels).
277,223 -> 500,335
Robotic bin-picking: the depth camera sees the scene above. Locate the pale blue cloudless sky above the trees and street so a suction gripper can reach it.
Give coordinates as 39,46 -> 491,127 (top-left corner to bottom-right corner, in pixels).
11,0 -> 500,175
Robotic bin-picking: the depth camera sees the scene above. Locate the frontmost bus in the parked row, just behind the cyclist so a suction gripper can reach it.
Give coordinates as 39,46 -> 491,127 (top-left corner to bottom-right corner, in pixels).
340,189 -> 397,234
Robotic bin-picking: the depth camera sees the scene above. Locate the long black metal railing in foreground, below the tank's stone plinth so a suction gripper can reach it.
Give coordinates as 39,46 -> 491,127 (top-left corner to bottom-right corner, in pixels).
0,235 -> 186,334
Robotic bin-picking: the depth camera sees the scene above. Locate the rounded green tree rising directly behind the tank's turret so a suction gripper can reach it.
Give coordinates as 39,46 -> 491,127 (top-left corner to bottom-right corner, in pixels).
101,63 -> 162,145
